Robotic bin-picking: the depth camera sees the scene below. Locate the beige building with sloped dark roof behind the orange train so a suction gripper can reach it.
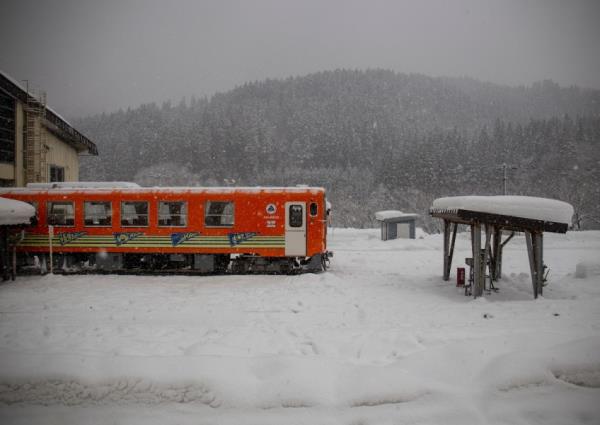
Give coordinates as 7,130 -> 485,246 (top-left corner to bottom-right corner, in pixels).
0,71 -> 98,187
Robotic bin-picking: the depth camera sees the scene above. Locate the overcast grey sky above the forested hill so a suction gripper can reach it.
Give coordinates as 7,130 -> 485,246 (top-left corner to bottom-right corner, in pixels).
0,0 -> 600,117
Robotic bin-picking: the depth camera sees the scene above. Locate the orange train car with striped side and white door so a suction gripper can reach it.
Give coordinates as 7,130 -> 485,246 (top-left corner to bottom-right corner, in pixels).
0,183 -> 332,273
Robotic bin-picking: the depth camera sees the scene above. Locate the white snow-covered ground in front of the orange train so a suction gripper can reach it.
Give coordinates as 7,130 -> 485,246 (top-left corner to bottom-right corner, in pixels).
0,229 -> 600,425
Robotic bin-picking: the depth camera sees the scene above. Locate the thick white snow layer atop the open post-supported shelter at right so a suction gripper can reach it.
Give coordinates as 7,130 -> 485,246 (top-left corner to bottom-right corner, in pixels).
432,196 -> 573,224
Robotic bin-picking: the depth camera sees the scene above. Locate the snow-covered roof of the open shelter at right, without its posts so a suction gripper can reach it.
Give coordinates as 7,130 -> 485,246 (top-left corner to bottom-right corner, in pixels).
430,196 -> 573,233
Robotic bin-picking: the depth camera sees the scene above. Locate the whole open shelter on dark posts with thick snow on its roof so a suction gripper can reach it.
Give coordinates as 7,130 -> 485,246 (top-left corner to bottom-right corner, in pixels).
430,196 -> 573,298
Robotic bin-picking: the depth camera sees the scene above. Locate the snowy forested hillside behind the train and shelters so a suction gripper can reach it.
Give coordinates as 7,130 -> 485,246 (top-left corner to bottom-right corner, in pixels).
75,70 -> 600,228
